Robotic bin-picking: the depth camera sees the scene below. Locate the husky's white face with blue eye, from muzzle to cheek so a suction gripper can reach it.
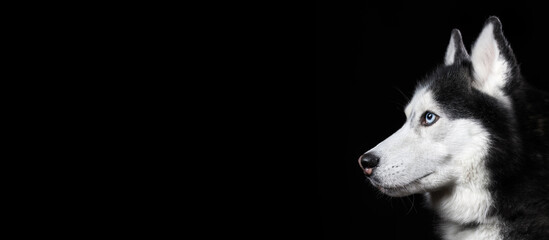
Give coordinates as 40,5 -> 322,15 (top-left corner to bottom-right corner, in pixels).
361,87 -> 488,196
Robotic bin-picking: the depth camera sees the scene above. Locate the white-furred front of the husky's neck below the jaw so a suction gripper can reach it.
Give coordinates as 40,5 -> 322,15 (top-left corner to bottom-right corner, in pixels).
426,181 -> 501,240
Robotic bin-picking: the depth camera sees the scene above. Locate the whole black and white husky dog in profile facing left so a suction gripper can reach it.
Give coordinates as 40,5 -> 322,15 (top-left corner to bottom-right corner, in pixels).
358,17 -> 549,240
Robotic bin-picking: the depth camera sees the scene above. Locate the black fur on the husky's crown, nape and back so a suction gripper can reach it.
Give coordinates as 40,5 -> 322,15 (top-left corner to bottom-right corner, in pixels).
422,17 -> 549,240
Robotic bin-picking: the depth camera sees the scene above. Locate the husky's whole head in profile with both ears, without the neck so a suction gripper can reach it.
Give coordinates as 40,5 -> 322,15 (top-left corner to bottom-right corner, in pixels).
359,18 -> 518,197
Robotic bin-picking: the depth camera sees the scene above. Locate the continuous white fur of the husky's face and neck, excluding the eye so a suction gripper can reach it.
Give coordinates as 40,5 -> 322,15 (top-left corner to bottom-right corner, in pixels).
364,86 -> 501,240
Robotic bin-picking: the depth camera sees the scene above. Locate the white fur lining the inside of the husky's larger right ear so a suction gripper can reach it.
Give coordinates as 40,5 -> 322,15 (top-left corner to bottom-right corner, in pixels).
471,23 -> 511,106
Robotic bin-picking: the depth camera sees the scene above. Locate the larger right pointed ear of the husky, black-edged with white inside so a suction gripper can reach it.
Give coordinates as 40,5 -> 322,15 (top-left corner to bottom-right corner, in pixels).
471,17 -> 518,101
